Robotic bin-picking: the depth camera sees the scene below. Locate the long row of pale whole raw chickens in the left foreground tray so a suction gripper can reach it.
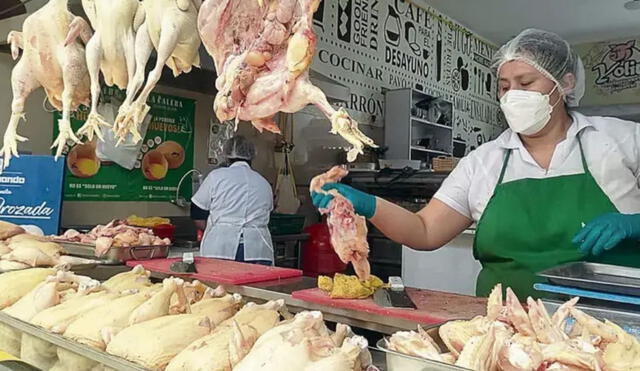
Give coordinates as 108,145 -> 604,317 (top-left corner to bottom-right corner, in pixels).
0,266 -> 371,371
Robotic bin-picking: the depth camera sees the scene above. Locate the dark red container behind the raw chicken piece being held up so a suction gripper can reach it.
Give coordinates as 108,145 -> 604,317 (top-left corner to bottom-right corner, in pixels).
302,223 -> 347,277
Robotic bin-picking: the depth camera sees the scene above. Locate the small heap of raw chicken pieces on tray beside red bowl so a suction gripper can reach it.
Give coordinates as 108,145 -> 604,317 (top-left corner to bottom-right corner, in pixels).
53,220 -> 171,256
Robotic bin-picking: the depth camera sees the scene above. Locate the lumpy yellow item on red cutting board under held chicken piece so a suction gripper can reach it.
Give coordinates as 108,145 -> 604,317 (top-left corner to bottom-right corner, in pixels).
318,273 -> 384,299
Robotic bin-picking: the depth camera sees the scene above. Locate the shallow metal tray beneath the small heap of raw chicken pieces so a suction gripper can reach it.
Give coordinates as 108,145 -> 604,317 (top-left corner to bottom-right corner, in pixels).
60,242 -> 171,264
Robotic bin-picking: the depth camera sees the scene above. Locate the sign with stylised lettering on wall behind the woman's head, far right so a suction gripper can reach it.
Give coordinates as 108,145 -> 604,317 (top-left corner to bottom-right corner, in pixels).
576,38 -> 640,106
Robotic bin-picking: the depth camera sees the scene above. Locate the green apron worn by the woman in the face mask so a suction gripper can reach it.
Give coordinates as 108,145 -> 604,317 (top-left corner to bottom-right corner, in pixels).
473,136 -> 640,299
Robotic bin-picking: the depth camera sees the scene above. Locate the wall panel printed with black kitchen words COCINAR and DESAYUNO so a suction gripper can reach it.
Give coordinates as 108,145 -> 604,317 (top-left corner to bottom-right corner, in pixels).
313,0 -> 506,152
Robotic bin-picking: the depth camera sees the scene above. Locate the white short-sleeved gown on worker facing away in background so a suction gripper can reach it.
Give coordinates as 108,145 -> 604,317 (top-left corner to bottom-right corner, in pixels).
191,162 -> 273,261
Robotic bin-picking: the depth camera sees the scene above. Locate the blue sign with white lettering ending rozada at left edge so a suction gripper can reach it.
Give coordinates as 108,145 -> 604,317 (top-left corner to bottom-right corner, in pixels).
0,155 -> 65,235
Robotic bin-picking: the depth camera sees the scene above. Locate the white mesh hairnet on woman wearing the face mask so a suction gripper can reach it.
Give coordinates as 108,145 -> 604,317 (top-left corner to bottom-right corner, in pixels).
493,28 -> 586,107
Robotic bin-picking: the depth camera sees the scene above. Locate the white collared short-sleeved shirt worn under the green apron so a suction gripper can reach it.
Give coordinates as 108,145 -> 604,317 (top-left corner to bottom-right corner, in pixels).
433,112 -> 640,222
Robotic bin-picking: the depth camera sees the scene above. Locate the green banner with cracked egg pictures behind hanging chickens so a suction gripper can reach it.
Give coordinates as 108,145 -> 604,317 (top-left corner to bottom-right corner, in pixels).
53,87 -> 195,201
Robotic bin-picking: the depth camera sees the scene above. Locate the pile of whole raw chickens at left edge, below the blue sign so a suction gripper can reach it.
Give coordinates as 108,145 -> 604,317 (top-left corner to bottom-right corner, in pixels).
0,221 -> 95,272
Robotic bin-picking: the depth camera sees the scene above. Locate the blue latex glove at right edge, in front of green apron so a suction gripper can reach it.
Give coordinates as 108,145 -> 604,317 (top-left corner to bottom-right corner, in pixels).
571,213 -> 640,255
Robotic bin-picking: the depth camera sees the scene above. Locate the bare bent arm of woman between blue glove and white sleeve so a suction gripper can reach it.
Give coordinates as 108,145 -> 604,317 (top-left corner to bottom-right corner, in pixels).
370,198 -> 472,250
